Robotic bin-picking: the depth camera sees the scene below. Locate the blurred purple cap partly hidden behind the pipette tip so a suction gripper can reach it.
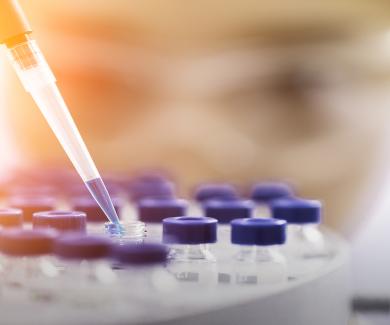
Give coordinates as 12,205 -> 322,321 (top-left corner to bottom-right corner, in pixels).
71,196 -> 123,222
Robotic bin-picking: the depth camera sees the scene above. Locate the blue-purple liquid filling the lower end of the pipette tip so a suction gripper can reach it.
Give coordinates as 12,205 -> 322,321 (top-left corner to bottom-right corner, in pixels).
85,178 -> 122,225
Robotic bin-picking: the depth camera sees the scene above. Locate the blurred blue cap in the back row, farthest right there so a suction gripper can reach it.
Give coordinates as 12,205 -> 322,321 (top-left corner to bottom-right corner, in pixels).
251,182 -> 294,202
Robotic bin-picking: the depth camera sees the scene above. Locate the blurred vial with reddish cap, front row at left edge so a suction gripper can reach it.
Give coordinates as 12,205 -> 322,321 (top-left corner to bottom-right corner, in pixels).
0,228 -> 59,302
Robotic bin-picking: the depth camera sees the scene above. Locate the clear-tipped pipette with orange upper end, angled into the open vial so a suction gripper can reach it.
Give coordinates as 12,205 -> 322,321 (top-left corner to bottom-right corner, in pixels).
0,0 -> 119,225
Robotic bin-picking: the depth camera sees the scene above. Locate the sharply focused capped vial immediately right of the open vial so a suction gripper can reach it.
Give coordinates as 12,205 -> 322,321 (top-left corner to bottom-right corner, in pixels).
163,217 -> 217,287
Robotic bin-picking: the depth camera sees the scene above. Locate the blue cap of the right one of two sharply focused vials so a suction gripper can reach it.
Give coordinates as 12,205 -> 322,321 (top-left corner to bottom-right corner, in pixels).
231,218 -> 286,246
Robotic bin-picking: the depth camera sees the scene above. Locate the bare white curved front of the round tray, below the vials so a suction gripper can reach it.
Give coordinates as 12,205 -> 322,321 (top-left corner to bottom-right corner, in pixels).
0,227 -> 349,325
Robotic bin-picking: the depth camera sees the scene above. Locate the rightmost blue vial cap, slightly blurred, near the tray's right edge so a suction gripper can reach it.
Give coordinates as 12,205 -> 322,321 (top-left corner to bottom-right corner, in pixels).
271,198 -> 321,224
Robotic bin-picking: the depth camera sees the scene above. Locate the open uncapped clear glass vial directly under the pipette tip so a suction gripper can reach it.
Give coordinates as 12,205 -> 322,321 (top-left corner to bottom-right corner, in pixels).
104,221 -> 146,244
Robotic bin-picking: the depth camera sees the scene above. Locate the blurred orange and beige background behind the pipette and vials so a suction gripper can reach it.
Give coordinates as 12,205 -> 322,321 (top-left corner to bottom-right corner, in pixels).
0,0 -> 390,321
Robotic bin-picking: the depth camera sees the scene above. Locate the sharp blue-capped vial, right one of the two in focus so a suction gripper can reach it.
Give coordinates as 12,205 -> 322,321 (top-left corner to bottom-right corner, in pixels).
218,218 -> 287,286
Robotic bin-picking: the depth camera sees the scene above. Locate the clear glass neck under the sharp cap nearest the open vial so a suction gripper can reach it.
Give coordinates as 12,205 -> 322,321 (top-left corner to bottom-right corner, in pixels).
169,244 -> 215,262
